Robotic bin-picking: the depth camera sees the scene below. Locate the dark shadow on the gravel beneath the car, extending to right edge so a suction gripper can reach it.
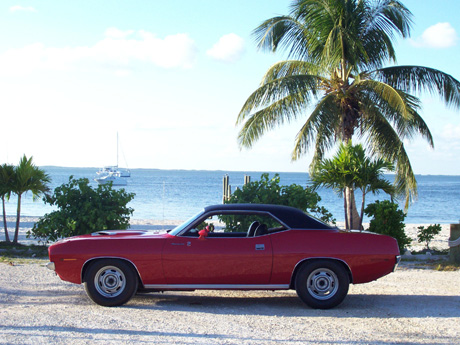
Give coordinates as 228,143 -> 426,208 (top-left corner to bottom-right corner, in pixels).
122,293 -> 460,318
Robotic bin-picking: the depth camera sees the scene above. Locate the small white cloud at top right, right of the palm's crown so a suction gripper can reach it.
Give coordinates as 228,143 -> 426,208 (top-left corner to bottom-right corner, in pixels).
411,23 -> 458,48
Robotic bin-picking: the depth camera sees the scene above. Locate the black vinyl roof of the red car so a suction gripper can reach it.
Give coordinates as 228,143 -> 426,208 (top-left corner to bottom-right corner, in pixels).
204,204 -> 331,229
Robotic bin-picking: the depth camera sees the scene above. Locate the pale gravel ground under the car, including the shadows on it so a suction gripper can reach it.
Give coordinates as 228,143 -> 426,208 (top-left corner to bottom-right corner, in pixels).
0,261 -> 460,345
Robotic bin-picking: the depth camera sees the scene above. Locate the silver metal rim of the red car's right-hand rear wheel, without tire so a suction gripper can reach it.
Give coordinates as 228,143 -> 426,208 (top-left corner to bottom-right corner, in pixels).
307,268 -> 339,300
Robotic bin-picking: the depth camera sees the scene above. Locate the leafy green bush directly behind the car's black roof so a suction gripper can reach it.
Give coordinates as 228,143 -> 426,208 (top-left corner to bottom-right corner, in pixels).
225,173 -> 335,225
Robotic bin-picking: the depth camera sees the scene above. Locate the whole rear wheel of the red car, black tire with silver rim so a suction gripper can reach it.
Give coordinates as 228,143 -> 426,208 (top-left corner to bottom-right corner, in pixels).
295,260 -> 350,309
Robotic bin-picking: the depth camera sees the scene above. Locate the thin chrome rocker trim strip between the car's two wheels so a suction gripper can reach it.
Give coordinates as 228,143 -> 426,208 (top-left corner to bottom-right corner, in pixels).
144,284 -> 289,290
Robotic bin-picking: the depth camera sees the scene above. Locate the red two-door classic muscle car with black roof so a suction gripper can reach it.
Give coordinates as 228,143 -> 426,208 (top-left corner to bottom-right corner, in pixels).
47,204 -> 400,309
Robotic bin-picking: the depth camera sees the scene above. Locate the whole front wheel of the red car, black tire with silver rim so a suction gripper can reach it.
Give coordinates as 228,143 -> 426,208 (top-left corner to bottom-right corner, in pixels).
85,259 -> 138,307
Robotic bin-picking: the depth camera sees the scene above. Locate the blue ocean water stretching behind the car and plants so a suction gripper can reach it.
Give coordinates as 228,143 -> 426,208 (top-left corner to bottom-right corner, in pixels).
6,167 -> 460,224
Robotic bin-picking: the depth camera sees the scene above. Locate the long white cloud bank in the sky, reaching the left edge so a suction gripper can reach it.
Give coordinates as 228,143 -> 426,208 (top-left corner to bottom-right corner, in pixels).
0,28 -> 197,75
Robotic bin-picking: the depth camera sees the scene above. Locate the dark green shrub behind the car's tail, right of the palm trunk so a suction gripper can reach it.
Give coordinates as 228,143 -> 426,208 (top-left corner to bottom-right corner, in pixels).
364,200 -> 411,253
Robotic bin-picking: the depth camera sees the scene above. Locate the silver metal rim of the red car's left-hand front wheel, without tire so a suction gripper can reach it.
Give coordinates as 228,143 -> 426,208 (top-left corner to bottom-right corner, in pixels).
94,266 -> 126,298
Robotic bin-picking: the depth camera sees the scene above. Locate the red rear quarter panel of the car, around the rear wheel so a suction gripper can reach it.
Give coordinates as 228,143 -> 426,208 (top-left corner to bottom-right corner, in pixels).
271,229 -> 399,284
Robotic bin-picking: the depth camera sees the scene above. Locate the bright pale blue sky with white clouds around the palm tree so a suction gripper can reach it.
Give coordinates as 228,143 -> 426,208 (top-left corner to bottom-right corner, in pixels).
0,0 -> 460,175
